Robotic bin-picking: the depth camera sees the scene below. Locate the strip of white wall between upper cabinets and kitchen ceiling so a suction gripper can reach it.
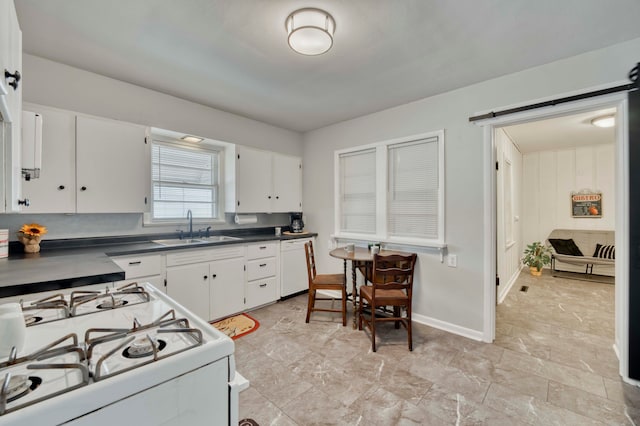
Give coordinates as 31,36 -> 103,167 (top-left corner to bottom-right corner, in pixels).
23,54 -> 302,156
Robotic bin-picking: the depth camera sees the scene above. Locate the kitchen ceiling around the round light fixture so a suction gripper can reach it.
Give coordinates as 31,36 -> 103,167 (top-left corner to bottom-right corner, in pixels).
15,0 -> 640,132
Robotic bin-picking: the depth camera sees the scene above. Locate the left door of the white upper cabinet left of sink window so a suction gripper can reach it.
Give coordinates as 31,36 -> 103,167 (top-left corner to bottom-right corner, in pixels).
22,104 -> 76,213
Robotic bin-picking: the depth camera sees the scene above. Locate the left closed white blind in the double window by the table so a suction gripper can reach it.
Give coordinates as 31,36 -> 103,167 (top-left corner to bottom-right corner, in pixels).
339,149 -> 376,234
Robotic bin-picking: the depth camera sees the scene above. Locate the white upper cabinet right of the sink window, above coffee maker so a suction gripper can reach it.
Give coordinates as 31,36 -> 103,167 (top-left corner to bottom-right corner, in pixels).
226,146 -> 302,213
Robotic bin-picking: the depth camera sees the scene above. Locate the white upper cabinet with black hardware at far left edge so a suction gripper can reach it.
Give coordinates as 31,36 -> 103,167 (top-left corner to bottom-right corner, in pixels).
0,0 -> 22,212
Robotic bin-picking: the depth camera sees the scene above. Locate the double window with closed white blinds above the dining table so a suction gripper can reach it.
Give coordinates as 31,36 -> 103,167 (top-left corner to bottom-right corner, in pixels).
335,131 -> 444,247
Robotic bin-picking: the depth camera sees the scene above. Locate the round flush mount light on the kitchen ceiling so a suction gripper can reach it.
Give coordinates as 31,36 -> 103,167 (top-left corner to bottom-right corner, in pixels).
284,7 -> 336,56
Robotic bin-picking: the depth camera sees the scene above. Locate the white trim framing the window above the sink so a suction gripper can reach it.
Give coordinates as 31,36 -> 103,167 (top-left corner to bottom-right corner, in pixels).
143,135 -> 226,227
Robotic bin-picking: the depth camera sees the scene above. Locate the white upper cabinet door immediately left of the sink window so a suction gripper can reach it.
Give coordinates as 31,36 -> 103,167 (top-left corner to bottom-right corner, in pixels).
76,116 -> 151,213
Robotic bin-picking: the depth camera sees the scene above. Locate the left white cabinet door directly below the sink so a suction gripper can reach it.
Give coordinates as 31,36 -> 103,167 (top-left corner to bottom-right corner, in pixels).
167,263 -> 209,321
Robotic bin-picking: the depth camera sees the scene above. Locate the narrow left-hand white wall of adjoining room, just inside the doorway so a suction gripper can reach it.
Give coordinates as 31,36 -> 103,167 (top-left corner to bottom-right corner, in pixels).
495,129 -> 528,303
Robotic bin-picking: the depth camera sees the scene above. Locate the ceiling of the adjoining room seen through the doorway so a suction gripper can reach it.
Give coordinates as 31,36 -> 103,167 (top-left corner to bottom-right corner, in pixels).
503,108 -> 616,154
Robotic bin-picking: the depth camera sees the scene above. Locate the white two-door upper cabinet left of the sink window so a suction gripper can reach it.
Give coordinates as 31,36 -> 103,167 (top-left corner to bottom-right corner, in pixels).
22,104 -> 151,213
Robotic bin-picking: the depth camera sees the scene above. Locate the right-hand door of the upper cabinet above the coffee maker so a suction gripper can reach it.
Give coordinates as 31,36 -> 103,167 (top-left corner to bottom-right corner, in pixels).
272,154 -> 302,213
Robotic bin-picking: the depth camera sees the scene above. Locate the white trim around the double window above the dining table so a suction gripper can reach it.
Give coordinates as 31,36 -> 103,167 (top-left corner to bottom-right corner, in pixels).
332,129 -> 446,249
